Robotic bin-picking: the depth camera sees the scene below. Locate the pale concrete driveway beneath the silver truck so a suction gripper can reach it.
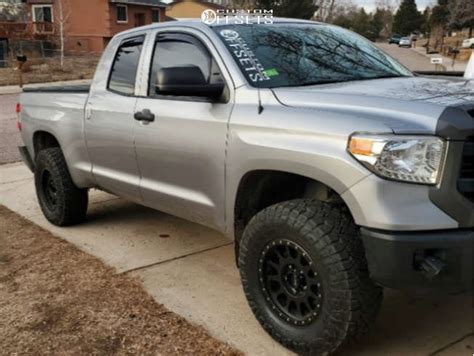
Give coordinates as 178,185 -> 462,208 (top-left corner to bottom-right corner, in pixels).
0,163 -> 474,355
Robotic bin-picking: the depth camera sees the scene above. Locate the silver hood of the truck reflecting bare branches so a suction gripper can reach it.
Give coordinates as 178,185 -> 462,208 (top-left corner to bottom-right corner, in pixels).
273,77 -> 474,134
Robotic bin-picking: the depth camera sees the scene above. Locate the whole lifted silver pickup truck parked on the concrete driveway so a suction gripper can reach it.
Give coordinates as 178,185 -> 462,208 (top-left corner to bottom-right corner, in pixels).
19,20 -> 474,353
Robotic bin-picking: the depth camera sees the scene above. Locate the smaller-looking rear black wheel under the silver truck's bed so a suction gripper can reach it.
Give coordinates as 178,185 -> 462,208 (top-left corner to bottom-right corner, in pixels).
35,148 -> 88,226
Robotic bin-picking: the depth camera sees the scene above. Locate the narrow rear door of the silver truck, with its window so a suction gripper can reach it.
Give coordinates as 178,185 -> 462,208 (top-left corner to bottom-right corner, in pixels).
85,36 -> 144,201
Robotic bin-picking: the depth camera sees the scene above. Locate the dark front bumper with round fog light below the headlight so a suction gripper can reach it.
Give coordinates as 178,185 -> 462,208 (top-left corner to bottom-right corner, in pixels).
361,228 -> 474,294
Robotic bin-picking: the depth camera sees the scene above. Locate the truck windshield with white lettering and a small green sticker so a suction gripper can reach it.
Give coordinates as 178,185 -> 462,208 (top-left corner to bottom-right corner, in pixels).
213,24 -> 412,88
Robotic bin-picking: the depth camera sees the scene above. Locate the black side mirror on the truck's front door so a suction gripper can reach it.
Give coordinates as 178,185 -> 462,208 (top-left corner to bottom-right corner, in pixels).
156,66 -> 225,99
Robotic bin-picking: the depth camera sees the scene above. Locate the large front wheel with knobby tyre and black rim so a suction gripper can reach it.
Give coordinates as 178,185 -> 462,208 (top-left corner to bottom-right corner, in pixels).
239,200 -> 383,354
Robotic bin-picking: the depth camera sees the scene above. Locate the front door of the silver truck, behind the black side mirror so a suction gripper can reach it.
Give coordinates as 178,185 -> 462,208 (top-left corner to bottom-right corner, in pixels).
135,30 -> 232,228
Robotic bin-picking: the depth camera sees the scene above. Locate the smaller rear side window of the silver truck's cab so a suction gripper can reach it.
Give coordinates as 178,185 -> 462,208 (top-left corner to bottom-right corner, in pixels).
108,36 -> 145,95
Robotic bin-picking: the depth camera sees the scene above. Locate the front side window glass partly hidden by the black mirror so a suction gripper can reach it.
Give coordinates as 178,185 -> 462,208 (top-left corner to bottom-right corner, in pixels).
149,34 -> 224,96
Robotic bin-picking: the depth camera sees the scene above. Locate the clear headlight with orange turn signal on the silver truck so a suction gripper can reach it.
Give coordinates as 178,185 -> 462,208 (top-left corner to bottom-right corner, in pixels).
348,134 -> 445,184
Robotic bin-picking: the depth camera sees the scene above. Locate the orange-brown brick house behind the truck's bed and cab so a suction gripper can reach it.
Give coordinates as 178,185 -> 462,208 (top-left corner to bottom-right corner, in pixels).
0,0 -> 168,62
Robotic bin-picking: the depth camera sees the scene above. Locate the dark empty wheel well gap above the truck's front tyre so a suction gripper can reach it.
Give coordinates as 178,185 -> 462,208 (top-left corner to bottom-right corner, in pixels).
234,170 -> 345,248
